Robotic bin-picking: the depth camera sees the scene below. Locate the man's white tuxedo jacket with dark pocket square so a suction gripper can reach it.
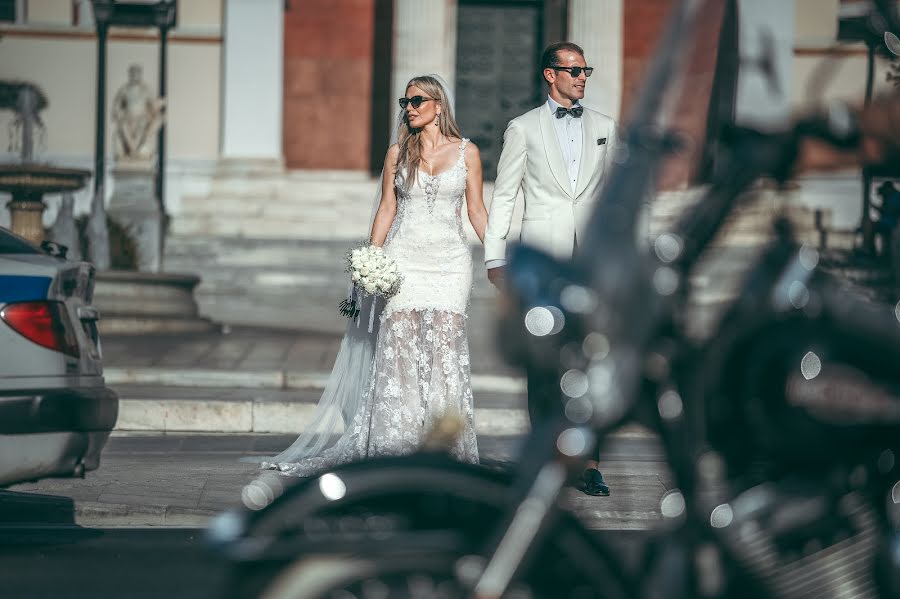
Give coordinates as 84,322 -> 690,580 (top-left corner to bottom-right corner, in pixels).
484,104 -> 616,261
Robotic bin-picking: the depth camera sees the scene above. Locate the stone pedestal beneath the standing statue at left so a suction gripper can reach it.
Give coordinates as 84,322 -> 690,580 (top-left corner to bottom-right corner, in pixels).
107,164 -> 165,272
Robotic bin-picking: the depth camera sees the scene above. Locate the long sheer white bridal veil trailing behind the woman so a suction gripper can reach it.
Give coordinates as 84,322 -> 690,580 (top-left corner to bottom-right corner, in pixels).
263,74 -> 454,466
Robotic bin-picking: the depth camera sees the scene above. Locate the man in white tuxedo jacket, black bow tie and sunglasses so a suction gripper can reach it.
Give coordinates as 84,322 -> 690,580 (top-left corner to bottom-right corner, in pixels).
484,42 -> 616,495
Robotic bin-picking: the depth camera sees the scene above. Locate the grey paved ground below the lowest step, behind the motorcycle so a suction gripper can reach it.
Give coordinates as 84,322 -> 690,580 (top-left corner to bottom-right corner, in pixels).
0,431 -> 672,529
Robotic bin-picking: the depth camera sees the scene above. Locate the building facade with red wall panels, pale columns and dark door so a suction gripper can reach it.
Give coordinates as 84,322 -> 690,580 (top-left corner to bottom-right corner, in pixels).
0,0 -> 886,230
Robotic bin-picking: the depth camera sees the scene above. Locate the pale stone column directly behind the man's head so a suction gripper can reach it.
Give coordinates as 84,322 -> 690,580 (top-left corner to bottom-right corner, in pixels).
568,0 -> 624,120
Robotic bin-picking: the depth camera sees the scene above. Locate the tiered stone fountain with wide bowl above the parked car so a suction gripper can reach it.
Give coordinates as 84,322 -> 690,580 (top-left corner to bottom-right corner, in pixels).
0,82 -> 91,245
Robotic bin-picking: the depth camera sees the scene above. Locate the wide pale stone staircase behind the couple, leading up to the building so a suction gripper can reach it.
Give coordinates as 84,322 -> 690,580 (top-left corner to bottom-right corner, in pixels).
165,172 -> 827,332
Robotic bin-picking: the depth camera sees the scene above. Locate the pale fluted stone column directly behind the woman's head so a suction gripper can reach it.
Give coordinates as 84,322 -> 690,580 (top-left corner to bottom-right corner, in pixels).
390,0 -> 456,133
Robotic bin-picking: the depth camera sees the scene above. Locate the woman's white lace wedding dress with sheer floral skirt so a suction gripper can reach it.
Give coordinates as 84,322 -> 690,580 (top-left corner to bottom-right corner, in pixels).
264,139 -> 478,476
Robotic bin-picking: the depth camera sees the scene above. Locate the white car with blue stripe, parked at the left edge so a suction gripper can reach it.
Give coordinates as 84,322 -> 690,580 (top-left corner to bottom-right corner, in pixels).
0,227 -> 119,487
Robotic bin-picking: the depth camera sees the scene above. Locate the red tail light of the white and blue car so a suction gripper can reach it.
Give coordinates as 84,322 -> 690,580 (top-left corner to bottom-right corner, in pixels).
0,301 -> 79,358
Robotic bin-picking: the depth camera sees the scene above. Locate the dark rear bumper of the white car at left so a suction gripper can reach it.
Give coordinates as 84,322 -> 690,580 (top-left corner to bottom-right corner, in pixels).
0,387 -> 119,486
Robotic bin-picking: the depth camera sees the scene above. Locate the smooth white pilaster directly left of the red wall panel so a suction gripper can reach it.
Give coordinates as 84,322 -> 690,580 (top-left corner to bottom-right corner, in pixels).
221,0 -> 284,164
